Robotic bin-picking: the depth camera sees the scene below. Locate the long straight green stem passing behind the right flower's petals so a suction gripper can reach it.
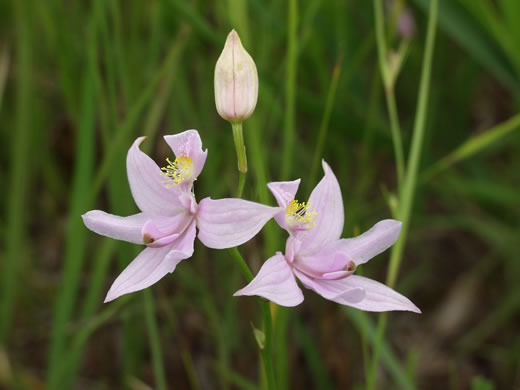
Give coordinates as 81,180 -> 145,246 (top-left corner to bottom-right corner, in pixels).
367,0 -> 439,389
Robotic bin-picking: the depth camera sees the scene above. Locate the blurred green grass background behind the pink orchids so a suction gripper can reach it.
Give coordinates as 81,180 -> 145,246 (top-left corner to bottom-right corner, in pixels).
0,0 -> 520,390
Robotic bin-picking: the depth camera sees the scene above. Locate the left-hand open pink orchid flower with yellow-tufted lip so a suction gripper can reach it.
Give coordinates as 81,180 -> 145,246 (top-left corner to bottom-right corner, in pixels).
83,130 -> 280,302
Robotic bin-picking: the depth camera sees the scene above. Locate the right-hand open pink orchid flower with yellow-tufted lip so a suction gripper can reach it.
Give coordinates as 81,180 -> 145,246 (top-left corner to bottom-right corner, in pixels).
234,162 -> 421,313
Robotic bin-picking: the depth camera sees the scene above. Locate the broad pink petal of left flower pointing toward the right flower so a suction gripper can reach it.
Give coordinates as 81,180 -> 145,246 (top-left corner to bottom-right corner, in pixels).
197,198 -> 280,249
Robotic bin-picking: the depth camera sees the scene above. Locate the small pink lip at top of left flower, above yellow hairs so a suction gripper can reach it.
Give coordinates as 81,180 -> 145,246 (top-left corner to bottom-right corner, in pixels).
164,130 -> 208,179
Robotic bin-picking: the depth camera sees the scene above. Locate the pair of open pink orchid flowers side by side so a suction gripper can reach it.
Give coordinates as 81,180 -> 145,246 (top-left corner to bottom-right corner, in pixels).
83,130 -> 420,312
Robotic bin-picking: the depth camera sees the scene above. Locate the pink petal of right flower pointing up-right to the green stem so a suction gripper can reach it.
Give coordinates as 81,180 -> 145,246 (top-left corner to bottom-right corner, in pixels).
336,219 -> 402,265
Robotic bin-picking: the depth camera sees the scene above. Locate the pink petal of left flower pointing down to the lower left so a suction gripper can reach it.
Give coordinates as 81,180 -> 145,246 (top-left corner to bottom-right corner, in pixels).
105,221 -> 196,303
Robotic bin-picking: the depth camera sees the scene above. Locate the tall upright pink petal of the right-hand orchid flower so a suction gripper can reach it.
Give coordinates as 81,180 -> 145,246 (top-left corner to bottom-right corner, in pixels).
299,161 -> 344,256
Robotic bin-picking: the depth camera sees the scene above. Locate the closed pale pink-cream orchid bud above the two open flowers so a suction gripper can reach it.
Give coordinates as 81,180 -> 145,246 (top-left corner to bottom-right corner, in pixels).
215,30 -> 258,123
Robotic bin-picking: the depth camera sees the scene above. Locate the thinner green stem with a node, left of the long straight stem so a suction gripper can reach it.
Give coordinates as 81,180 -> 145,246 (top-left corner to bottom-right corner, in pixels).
374,0 -> 404,189
